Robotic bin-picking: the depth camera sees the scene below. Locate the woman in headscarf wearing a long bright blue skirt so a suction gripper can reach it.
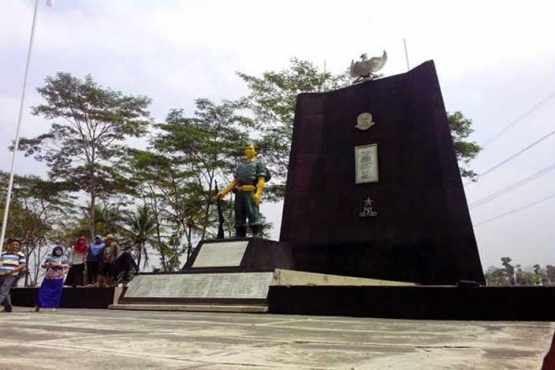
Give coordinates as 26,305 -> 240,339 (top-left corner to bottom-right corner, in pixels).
35,245 -> 69,312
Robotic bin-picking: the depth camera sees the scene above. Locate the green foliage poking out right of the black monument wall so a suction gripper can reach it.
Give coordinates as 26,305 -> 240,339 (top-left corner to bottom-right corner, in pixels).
447,111 -> 482,181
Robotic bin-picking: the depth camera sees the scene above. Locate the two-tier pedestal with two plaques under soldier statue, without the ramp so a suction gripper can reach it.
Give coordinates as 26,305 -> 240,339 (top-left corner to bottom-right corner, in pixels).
119,238 -> 294,311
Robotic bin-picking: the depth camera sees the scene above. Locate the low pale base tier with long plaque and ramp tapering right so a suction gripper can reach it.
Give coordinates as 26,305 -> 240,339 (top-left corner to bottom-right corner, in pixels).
110,269 -> 414,313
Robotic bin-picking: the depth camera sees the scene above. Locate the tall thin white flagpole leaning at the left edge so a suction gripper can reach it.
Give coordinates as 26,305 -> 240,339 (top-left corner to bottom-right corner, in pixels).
0,0 -> 39,253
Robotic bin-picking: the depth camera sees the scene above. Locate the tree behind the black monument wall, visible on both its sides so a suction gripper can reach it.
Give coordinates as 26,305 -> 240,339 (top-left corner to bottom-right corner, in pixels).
238,58 -> 481,200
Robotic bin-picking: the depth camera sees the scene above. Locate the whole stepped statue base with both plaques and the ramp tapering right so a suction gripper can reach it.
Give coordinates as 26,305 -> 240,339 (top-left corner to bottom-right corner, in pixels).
114,238 -> 414,312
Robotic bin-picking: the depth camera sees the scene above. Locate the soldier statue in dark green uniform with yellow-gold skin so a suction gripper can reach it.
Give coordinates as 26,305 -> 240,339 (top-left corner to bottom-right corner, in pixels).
217,144 -> 270,237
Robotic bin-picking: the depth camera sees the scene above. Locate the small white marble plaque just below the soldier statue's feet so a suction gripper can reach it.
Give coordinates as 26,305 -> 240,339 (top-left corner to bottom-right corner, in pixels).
192,240 -> 249,268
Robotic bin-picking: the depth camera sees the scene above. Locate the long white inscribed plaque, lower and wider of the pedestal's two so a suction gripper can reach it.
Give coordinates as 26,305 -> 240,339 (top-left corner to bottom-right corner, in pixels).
125,272 -> 273,299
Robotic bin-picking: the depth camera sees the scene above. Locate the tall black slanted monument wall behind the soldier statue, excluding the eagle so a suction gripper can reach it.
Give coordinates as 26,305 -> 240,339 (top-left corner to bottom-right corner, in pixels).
280,61 -> 484,284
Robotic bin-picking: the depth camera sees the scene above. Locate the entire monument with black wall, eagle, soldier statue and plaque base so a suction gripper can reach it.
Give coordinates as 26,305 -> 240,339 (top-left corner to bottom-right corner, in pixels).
114,56 -> 484,312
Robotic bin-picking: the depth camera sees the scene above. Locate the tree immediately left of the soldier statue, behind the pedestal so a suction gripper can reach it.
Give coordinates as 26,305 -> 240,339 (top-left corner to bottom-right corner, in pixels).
152,99 -> 253,241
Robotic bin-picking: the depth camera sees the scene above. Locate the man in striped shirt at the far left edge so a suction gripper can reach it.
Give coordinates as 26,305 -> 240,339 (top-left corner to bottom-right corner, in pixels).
0,238 -> 26,312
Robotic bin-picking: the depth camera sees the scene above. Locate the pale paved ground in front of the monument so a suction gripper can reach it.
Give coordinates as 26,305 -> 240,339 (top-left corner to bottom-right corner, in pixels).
0,308 -> 555,370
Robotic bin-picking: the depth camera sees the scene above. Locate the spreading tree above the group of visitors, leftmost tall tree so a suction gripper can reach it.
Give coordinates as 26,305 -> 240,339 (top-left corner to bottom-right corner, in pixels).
20,73 -> 151,238
